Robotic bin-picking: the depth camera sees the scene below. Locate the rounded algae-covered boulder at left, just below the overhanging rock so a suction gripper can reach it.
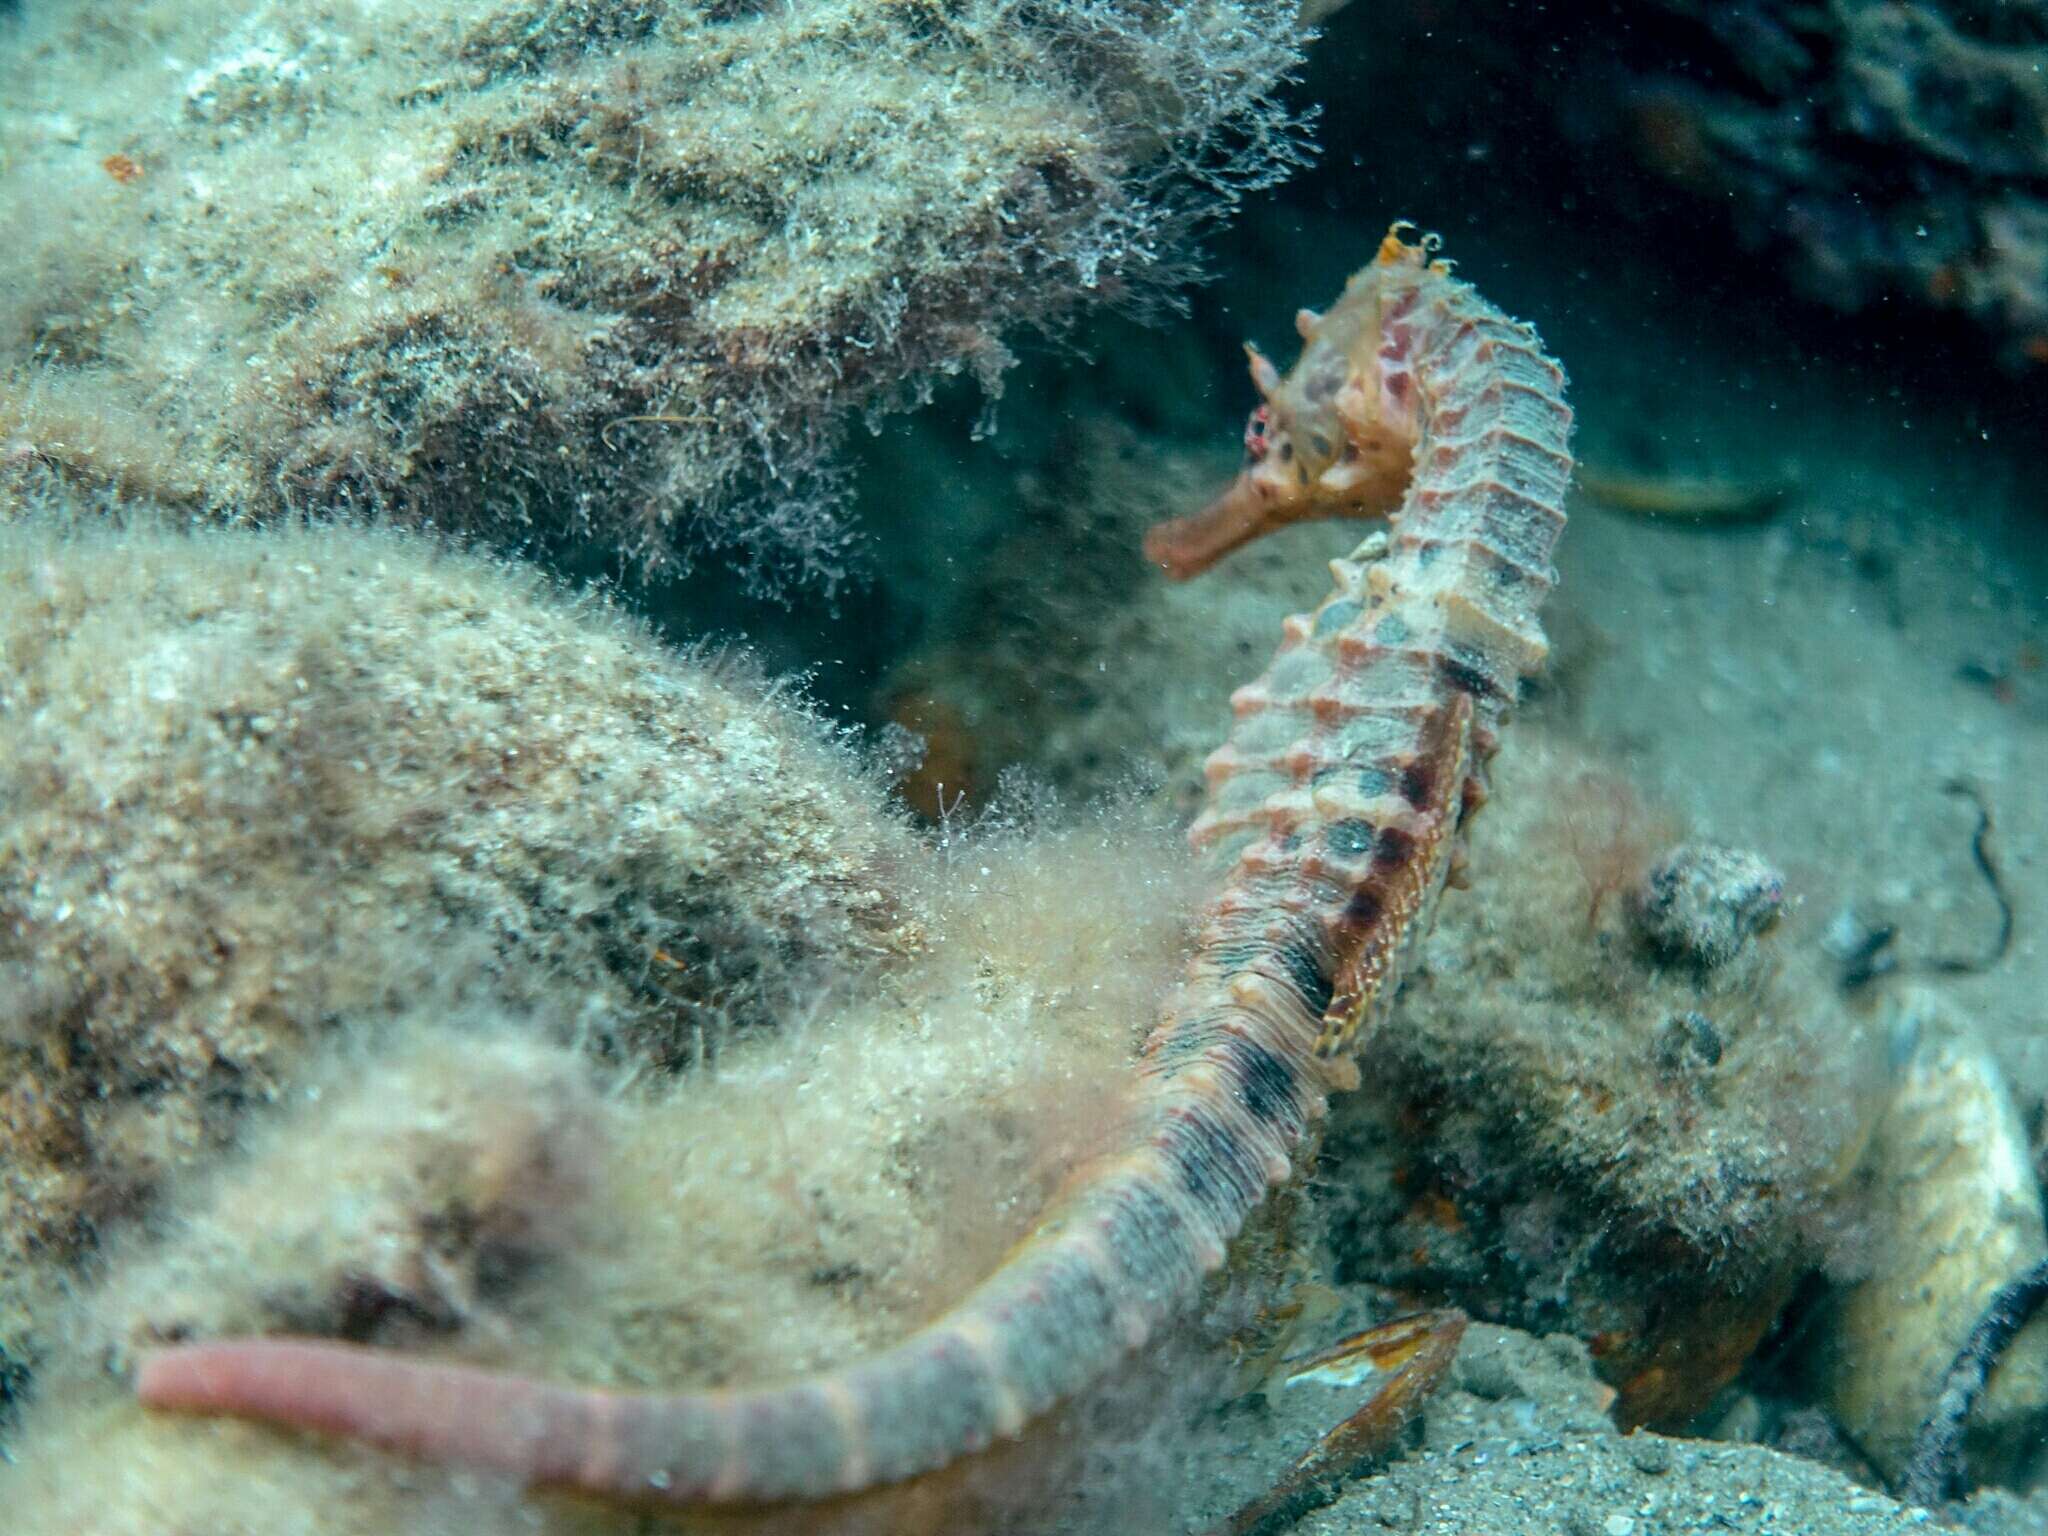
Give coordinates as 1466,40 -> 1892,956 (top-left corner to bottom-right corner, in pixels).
0,518 -> 922,1417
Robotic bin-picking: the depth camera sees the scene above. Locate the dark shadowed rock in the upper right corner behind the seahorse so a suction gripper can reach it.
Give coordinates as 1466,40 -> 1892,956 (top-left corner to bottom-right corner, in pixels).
1433,0 -> 2048,373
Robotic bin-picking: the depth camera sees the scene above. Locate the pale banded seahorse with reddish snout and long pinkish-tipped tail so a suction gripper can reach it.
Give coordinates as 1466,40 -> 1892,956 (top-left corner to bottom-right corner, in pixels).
137,225 -> 1571,1505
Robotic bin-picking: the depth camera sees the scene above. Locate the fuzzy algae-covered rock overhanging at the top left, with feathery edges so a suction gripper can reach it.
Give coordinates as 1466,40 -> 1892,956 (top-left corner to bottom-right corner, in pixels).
0,0 -> 1300,584
